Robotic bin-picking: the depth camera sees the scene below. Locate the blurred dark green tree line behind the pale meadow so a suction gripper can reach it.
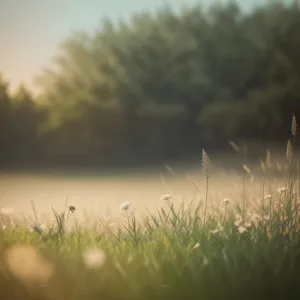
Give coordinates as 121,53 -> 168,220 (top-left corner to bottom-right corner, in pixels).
0,1 -> 300,165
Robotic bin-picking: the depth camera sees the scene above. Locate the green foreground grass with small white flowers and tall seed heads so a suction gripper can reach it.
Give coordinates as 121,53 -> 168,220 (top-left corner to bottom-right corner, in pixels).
0,120 -> 300,300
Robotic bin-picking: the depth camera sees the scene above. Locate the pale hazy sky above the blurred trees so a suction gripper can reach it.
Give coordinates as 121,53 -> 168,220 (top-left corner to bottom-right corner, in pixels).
0,0 -> 263,92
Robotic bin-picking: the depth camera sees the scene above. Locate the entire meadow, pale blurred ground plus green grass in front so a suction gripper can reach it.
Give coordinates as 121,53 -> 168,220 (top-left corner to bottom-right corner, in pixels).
0,125 -> 300,300
